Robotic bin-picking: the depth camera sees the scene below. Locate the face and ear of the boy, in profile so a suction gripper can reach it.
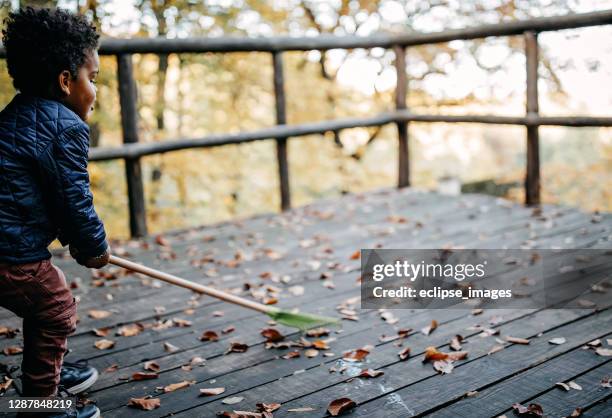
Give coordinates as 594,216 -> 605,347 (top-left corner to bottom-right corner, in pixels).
59,51 -> 100,121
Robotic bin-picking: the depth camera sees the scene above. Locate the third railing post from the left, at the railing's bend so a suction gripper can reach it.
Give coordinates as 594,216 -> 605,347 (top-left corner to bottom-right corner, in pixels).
393,45 -> 410,187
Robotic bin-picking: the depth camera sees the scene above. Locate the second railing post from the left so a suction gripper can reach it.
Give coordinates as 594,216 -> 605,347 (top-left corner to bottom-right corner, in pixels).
272,51 -> 291,210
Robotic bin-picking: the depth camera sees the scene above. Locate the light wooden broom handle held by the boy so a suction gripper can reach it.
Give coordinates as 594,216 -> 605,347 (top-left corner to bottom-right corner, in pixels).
109,255 -> 273,313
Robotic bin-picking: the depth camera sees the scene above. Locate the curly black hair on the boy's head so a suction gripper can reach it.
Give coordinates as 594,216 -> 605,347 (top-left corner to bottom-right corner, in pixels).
2,7 -> 100,96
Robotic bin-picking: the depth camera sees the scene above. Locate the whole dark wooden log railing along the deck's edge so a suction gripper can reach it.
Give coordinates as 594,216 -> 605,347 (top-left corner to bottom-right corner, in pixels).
0,10 -> 612,237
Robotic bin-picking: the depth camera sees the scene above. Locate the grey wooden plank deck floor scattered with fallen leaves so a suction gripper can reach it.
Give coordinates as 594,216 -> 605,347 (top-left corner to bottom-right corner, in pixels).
0,190 -> 612,418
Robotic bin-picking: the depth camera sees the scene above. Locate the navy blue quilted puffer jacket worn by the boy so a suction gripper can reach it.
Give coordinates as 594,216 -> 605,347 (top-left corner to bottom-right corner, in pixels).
0,94 -> 107,264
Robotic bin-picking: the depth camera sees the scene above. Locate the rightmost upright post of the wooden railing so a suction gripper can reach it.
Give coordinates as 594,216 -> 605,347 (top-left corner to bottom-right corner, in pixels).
524,31 -> 540,205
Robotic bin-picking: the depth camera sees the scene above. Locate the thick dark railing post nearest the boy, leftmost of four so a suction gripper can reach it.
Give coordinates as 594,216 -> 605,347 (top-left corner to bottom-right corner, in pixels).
117,54 -> 147,238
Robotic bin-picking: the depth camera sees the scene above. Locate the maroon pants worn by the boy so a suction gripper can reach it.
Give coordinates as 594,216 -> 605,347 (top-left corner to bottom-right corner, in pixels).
0,260 -> 76,396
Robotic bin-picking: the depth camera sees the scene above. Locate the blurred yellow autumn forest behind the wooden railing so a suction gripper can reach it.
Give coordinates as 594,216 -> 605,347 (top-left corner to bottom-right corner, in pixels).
0,0 -> 612,238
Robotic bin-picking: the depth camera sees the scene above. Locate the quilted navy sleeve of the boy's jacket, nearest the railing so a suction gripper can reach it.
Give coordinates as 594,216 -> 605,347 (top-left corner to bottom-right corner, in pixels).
40,123 -> 108,257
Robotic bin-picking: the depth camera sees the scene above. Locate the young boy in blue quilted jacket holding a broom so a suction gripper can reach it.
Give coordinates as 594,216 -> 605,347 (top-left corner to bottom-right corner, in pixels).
0,8 -> 109,418
